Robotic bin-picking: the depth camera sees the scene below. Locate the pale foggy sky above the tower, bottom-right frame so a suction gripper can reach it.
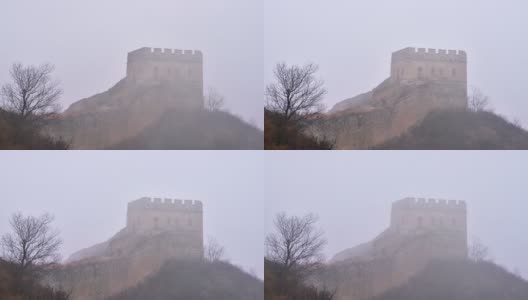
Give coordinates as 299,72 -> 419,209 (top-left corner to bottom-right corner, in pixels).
264,151 -> 528,278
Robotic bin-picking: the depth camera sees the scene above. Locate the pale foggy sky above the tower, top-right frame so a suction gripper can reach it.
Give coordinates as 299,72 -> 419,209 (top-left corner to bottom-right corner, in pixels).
264,0 -> 528,127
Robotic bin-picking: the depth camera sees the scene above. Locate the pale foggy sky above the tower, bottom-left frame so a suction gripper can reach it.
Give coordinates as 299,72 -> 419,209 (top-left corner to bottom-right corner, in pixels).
0,151 -> 264,278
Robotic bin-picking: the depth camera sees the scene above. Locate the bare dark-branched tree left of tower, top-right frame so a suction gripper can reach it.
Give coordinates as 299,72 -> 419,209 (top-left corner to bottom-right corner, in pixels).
266,63 -> 326,121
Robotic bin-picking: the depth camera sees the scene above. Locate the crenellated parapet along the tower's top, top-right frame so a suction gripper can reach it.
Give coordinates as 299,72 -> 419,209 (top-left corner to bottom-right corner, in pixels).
392,47 -> 467,63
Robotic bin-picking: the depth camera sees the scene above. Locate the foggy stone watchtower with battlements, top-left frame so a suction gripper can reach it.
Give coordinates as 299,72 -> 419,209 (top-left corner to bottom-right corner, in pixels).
126,47 -> 203,107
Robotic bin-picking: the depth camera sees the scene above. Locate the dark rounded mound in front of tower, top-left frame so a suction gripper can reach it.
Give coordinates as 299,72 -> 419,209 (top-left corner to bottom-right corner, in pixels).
109,109 -> 263,150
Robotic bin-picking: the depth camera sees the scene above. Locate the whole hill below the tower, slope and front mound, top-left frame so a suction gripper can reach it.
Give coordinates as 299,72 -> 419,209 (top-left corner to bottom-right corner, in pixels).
46,78 -> 263,149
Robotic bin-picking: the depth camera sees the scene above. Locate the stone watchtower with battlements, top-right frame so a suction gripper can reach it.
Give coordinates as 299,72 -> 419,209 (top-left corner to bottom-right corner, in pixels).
390,47 -> 467,108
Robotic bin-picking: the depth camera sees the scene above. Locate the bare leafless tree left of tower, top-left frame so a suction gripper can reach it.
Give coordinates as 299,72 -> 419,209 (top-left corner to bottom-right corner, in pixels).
0,63 -> 62,118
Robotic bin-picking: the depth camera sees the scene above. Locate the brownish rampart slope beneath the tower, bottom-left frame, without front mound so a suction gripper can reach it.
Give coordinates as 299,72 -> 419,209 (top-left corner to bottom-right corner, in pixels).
46,230 -> 201,300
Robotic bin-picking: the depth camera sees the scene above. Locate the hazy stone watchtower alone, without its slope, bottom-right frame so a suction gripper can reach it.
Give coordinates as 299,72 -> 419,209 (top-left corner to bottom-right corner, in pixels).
390,198 -> 467,258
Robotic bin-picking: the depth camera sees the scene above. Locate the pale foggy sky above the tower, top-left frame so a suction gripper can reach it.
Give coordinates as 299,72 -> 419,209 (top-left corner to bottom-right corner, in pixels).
0,0 -> 263,127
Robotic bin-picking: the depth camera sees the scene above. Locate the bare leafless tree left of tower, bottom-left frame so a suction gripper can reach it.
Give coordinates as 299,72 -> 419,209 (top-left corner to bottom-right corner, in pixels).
2,213 -> 62,271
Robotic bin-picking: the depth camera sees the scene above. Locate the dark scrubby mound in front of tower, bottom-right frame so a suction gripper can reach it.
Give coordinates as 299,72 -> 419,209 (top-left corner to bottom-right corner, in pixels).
373,261 -> 528,300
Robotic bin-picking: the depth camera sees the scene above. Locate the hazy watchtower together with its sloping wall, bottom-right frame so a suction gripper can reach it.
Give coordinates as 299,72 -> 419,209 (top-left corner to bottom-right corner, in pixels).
321,197 -> 467,299
